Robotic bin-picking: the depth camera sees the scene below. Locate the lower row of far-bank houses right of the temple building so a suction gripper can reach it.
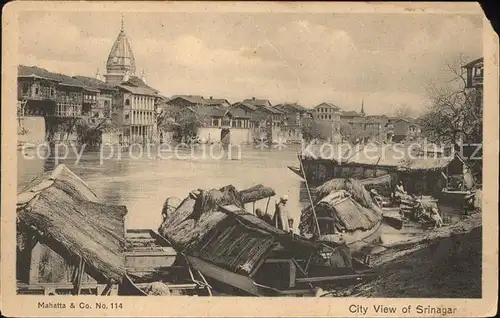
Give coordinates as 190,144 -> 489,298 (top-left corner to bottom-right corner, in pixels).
160,95 -> 420,143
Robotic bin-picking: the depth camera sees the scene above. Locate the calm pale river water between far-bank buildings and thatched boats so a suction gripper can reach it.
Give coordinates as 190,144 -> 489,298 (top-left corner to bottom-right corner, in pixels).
18,145 -> 308,229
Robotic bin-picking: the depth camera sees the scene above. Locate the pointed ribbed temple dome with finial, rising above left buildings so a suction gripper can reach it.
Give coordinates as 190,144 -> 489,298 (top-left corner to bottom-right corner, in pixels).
104,16 -> 135,85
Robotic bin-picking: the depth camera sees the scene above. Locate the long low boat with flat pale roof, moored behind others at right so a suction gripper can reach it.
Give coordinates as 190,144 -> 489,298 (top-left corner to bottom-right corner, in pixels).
288,144 -> 463,195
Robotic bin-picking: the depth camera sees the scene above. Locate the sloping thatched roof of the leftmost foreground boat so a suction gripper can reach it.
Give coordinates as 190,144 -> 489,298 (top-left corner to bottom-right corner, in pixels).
17,165 -> 127,282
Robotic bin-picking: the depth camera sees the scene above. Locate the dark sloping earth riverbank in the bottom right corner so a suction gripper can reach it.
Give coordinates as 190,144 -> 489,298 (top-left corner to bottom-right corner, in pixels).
328,213 -> 482,298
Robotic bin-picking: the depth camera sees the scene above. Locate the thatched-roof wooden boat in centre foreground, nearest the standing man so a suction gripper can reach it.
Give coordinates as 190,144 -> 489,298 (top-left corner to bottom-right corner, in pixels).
158,185 -> 374,296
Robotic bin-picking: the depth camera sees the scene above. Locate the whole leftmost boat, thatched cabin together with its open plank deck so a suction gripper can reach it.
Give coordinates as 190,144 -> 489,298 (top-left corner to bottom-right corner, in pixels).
16,165 -> 211,296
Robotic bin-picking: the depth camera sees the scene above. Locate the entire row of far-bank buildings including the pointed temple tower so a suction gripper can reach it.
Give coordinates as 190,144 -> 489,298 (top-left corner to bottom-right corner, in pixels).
18,21 -> 482,144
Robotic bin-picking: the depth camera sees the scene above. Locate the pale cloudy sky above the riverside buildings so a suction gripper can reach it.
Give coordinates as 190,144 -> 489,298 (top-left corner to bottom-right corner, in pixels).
19,12 -> 482,114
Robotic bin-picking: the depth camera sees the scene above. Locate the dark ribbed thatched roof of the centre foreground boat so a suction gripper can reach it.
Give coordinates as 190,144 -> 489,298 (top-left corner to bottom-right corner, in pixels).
158,185 -> 320,274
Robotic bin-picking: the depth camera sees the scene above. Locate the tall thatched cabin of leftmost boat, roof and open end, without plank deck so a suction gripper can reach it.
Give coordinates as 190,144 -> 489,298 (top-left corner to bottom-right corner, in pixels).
17,165 -> 127,295
